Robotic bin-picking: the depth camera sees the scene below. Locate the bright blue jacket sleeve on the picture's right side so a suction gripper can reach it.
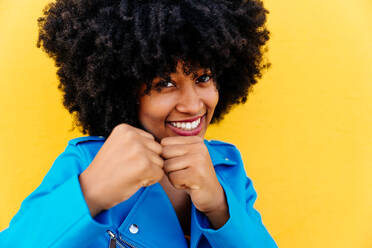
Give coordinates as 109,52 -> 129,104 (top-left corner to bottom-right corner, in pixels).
193,148 -> 277,248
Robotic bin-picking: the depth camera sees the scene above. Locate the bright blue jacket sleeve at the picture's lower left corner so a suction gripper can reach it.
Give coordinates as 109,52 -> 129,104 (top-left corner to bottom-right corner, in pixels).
0,144 -> 108,248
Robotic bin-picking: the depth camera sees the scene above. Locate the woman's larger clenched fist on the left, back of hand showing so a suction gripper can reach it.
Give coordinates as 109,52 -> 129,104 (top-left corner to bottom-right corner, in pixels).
79,124 -> 164,217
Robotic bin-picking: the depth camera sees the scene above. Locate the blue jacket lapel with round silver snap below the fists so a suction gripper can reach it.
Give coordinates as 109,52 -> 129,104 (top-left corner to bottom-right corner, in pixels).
118,183 -> 188,248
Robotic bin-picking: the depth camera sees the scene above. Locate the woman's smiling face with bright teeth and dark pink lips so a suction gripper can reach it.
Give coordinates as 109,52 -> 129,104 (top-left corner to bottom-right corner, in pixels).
138,62 -> 218,141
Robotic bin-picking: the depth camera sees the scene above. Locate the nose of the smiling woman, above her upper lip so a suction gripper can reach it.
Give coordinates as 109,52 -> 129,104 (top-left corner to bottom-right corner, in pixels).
176,85 -> 203,114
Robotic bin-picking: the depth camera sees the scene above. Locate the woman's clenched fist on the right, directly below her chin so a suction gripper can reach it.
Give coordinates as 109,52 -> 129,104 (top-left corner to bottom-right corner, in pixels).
161,136 -> 226,213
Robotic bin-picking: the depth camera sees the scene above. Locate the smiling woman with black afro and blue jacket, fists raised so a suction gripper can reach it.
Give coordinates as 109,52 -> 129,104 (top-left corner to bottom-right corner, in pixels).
0,0 -> 276,247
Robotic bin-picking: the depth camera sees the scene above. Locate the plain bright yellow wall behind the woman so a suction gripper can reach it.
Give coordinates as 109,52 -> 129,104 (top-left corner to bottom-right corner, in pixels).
0,0 -> 372,248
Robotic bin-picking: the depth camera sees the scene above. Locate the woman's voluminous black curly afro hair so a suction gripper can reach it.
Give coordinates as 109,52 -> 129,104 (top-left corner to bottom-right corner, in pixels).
37,0 -> 269,137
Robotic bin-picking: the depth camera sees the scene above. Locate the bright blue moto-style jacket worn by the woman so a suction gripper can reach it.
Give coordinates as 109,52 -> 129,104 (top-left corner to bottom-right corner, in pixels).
0,136 -> 277,248
